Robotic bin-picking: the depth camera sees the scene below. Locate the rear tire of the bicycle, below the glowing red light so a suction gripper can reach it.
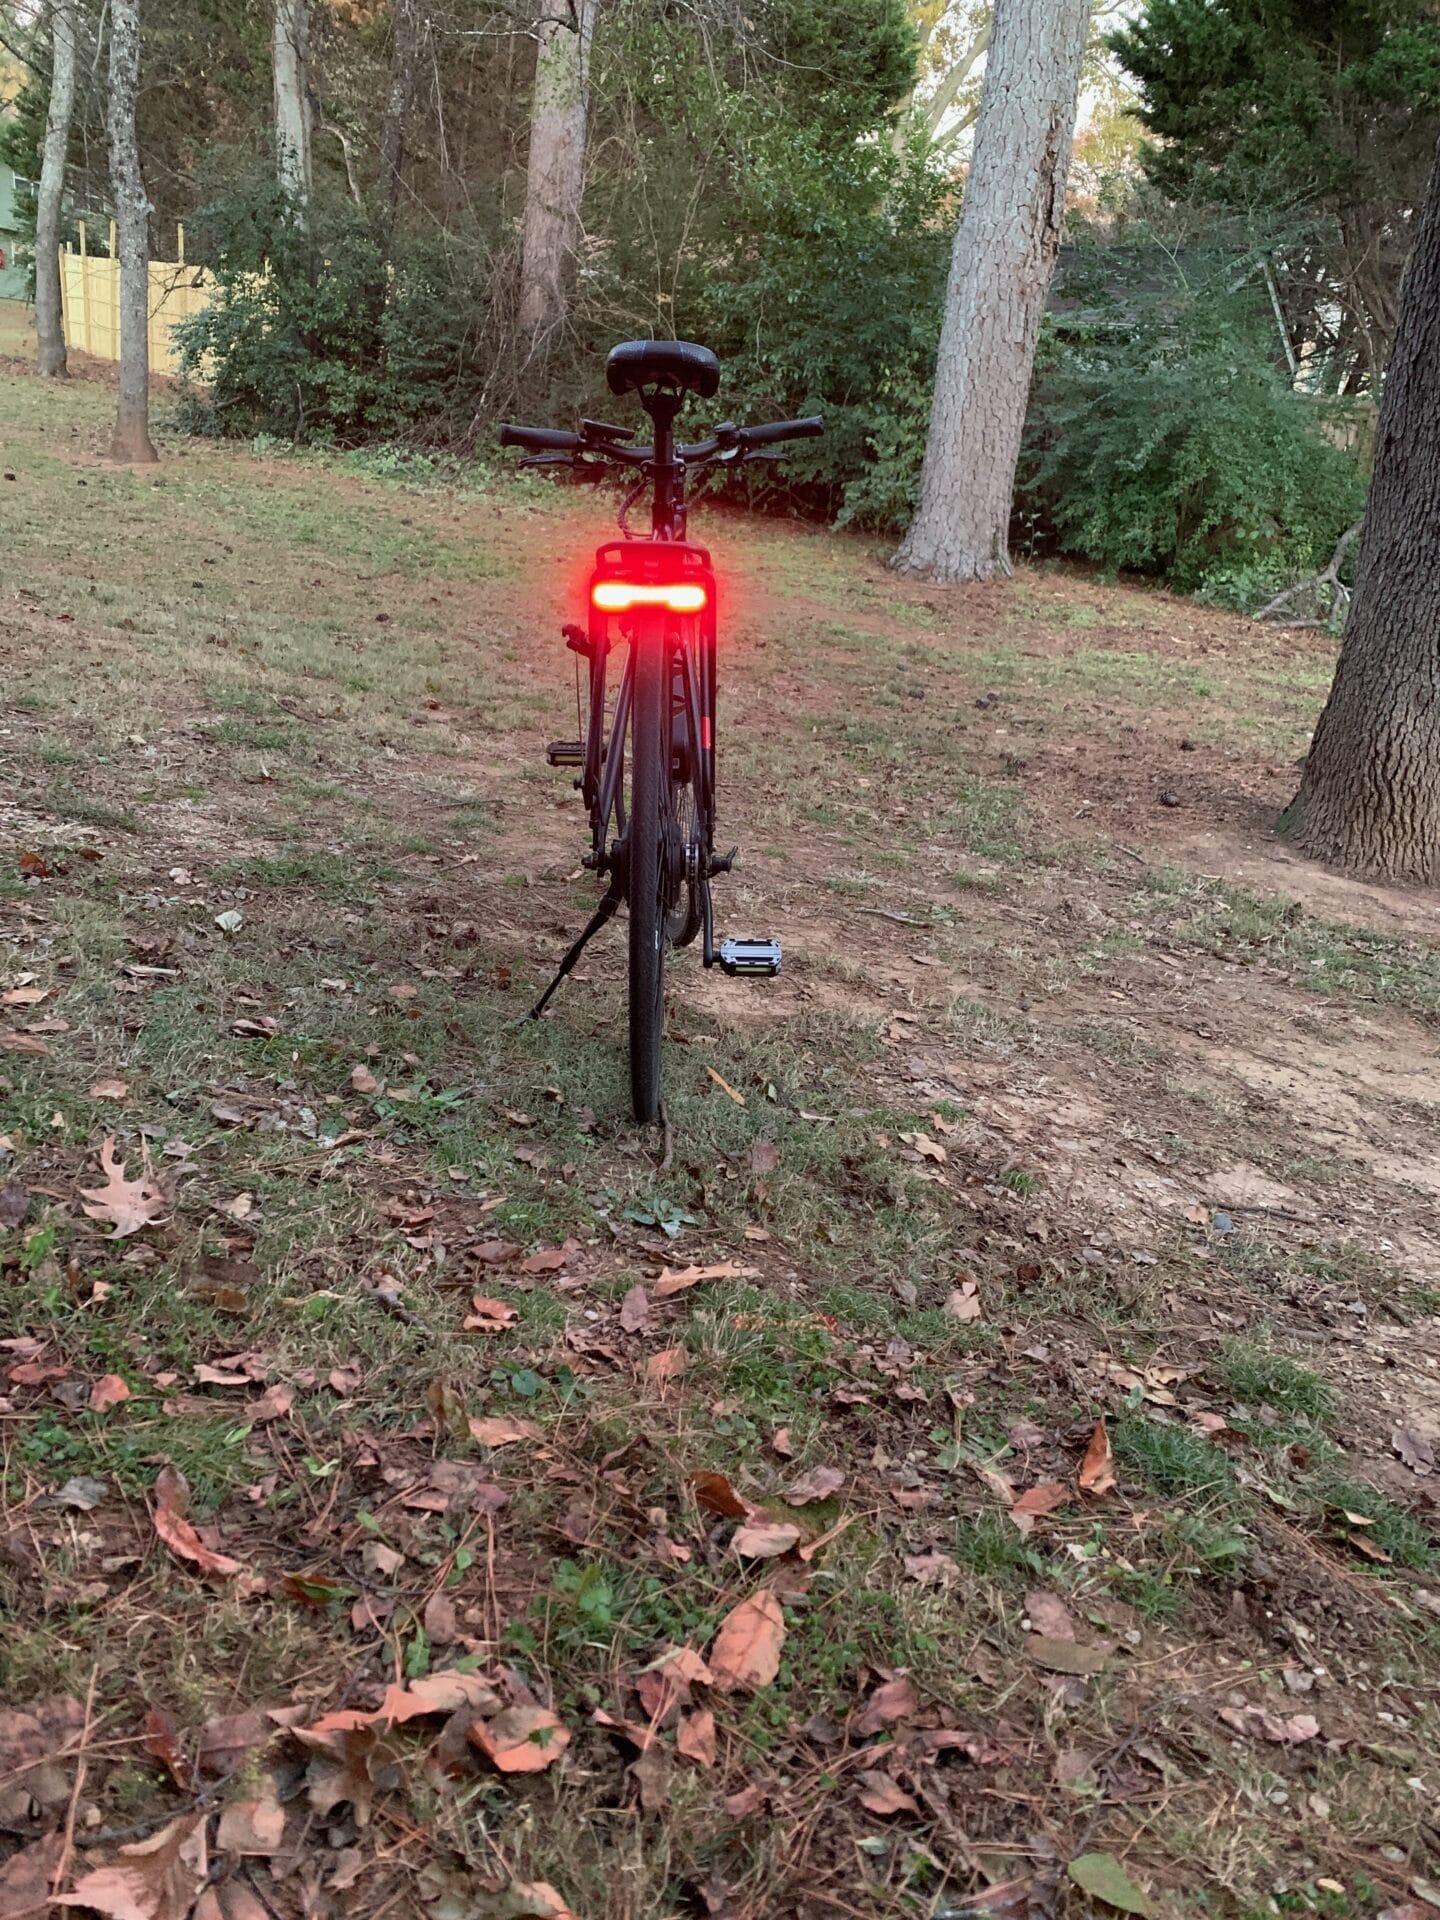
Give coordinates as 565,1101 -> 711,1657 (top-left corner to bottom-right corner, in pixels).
628,614 -> 670,1127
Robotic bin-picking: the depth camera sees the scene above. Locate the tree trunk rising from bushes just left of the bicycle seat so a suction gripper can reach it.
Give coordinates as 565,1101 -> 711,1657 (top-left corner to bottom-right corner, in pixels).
520,0 -> 597,334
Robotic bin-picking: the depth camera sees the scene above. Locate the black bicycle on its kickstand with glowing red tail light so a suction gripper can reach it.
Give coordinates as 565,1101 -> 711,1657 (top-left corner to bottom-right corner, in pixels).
499,340 -> 824,1123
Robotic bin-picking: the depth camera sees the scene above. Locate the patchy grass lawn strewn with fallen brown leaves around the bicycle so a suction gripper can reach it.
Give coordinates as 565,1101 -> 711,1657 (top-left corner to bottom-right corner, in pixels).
0,345 -> 1432,1920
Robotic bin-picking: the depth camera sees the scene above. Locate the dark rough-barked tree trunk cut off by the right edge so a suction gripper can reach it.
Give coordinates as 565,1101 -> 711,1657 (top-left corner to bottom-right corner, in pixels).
1283,135 -> 1440,881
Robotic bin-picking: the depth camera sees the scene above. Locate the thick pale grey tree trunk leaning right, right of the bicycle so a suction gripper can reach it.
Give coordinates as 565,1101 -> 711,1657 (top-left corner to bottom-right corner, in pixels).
893,0 -> 1091,582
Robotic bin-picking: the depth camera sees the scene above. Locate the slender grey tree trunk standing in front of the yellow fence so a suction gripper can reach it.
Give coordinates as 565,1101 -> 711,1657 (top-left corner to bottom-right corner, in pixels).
108,0 -> 157,461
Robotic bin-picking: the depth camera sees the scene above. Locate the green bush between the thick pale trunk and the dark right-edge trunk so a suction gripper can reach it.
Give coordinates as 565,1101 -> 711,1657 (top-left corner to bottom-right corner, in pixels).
1020,309 -> 1365,605
